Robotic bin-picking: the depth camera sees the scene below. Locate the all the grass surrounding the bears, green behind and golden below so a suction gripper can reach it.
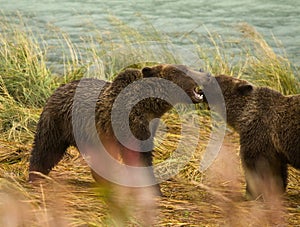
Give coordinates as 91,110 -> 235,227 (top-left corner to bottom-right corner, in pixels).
0,17 -> 300,226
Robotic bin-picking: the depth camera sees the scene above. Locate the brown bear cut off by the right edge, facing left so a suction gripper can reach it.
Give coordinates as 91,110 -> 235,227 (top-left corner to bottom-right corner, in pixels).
203,75 -> 300,200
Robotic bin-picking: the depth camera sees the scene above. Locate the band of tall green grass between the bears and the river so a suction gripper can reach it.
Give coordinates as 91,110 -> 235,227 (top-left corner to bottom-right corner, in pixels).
0,16 -> 300,142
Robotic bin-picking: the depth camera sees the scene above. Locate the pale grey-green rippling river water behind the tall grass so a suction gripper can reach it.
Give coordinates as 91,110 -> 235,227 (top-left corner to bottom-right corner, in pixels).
0,0 -> 300,70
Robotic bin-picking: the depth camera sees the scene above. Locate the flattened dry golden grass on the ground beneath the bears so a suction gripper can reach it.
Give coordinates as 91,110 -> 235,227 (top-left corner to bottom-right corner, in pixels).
0,113 -> 300,227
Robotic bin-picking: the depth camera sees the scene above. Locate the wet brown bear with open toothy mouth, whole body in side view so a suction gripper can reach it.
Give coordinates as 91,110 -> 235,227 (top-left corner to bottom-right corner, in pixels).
29,64 -> 210,193
